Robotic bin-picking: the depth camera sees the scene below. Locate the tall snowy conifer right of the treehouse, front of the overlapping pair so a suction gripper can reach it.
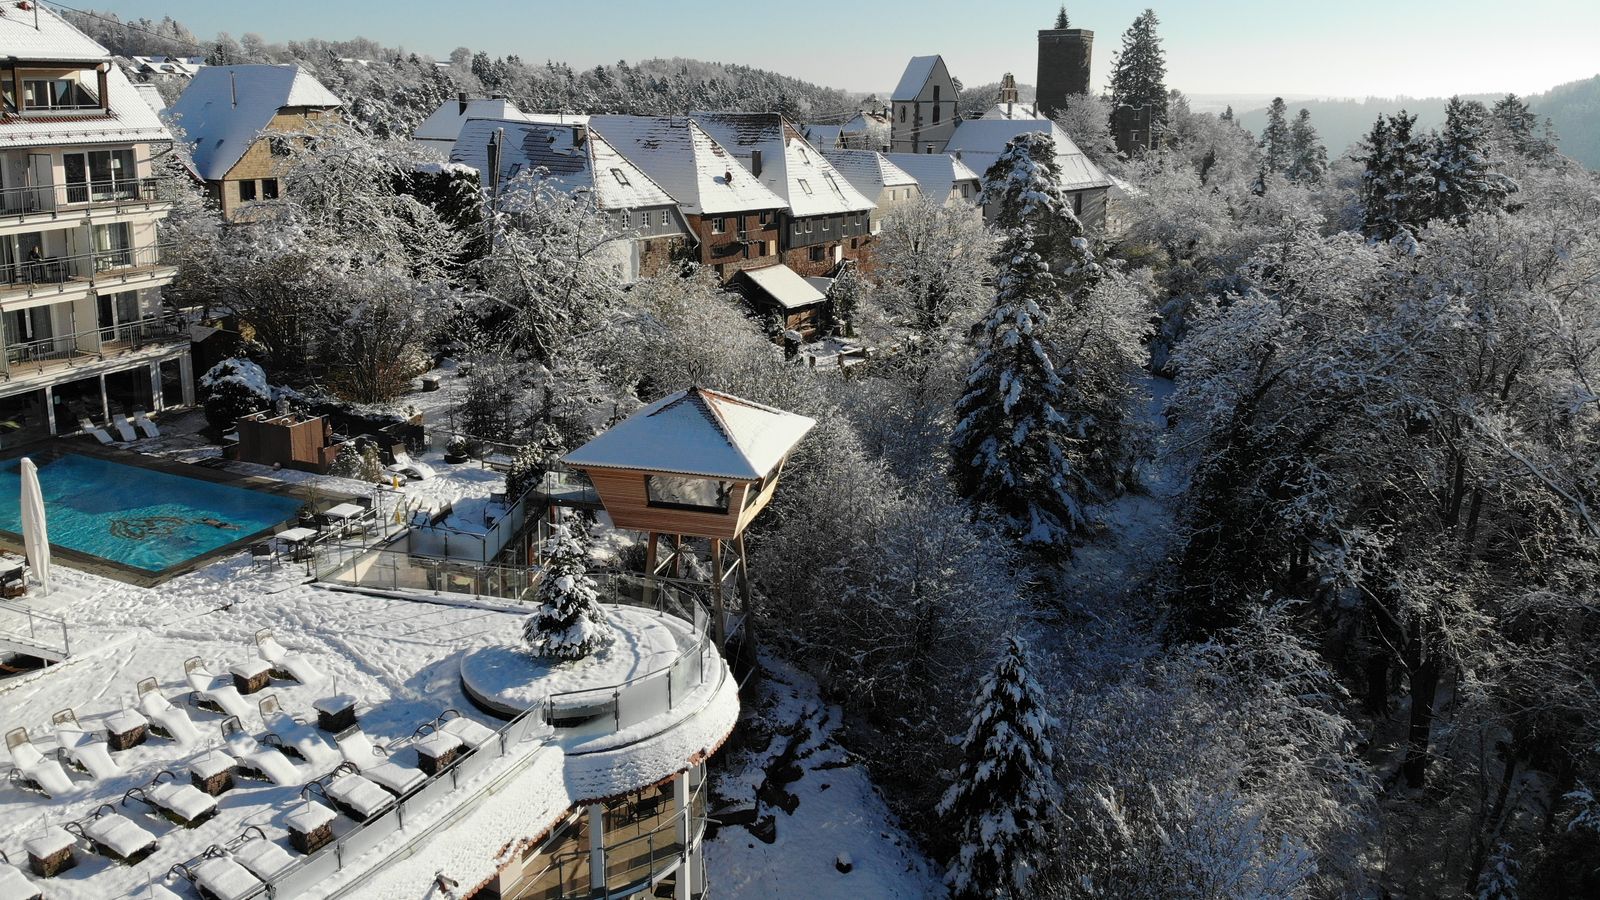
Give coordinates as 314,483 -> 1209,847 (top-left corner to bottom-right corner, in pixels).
950,223 -> 1090,548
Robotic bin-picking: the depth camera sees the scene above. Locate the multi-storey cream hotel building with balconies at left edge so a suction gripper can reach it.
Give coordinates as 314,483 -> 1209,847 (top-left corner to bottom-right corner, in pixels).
0,0 -> 194,444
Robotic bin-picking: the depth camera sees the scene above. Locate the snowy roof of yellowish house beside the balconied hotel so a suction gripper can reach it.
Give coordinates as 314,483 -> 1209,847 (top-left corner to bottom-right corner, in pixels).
166,66 -> 342,181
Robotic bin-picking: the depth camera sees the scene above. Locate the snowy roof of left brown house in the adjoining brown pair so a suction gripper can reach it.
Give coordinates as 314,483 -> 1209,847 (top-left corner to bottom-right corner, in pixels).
589,115 -> 789,215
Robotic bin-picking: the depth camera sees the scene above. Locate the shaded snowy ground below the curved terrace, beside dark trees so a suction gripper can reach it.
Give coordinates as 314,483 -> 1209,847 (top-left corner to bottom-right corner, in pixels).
706,657 -> 944,900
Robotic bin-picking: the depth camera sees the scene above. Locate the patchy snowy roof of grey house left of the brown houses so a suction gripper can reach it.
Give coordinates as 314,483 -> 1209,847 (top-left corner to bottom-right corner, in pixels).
450,119 -> 674,210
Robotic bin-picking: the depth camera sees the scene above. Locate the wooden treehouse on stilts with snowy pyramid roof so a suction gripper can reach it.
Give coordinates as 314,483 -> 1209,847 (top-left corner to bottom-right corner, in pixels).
562,388 -> 816,644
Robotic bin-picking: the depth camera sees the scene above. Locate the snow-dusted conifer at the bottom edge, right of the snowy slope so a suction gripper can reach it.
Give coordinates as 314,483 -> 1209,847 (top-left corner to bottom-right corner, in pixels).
939,637 -> 1056,898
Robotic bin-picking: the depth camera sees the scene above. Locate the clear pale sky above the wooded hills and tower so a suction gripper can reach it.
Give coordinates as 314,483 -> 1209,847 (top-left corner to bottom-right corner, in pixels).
70,0 -> 1600,96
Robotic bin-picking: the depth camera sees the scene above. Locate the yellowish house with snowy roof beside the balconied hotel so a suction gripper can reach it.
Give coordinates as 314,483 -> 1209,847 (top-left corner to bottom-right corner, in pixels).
166,66 -> 342,219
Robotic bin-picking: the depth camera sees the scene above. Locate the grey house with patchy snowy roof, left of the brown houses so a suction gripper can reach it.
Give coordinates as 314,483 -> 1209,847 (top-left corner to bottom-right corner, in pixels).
450,119 -> 691,282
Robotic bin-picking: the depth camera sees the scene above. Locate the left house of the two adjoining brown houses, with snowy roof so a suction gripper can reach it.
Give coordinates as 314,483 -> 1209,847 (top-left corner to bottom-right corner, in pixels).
589,115 -> 787,282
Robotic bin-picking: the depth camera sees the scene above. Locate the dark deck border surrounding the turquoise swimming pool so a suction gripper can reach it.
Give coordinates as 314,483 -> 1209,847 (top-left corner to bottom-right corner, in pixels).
0,436 -> 362,588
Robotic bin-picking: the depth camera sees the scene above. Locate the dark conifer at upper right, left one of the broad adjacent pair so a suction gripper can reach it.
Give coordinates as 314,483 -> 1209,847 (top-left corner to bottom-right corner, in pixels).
1355,110 -> 1434,240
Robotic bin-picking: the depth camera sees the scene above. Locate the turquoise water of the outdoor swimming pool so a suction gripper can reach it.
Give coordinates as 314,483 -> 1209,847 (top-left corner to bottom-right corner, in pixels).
0,453 -> 301,572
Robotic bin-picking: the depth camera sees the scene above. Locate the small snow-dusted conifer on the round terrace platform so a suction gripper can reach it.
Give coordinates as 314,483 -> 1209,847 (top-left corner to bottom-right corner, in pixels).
522,524 -> 616,660
